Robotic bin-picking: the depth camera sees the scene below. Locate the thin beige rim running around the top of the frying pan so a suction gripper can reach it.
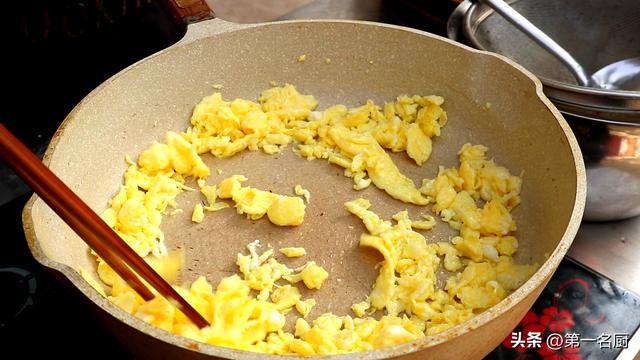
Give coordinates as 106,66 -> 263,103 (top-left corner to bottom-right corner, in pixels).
22,19 -> 586,359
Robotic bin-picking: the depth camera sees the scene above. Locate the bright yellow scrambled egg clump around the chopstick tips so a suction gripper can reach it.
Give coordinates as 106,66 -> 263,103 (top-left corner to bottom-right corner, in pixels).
94,240 -> 336,353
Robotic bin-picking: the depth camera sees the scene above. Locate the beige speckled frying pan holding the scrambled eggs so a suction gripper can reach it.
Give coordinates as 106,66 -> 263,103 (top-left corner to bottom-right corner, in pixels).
23,1 -> 585,359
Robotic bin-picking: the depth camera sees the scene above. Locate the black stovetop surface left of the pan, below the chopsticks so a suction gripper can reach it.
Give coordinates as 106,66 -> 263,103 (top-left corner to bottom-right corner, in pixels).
0,194 -> 133,359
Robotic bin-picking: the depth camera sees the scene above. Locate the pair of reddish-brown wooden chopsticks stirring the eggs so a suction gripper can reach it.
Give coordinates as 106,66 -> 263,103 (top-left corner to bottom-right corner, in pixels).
0,123 -> 209,328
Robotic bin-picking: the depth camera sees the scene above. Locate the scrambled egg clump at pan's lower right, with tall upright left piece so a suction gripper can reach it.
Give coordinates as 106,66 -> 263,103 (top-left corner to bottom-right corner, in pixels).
345,195 -> 537,335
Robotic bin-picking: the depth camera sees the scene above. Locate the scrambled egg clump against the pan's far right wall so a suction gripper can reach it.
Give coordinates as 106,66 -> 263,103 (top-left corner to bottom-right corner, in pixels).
420,144 -> 522,261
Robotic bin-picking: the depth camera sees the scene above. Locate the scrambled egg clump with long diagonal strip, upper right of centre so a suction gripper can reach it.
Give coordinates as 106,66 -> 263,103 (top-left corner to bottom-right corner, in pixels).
291,95 -> 447,205
